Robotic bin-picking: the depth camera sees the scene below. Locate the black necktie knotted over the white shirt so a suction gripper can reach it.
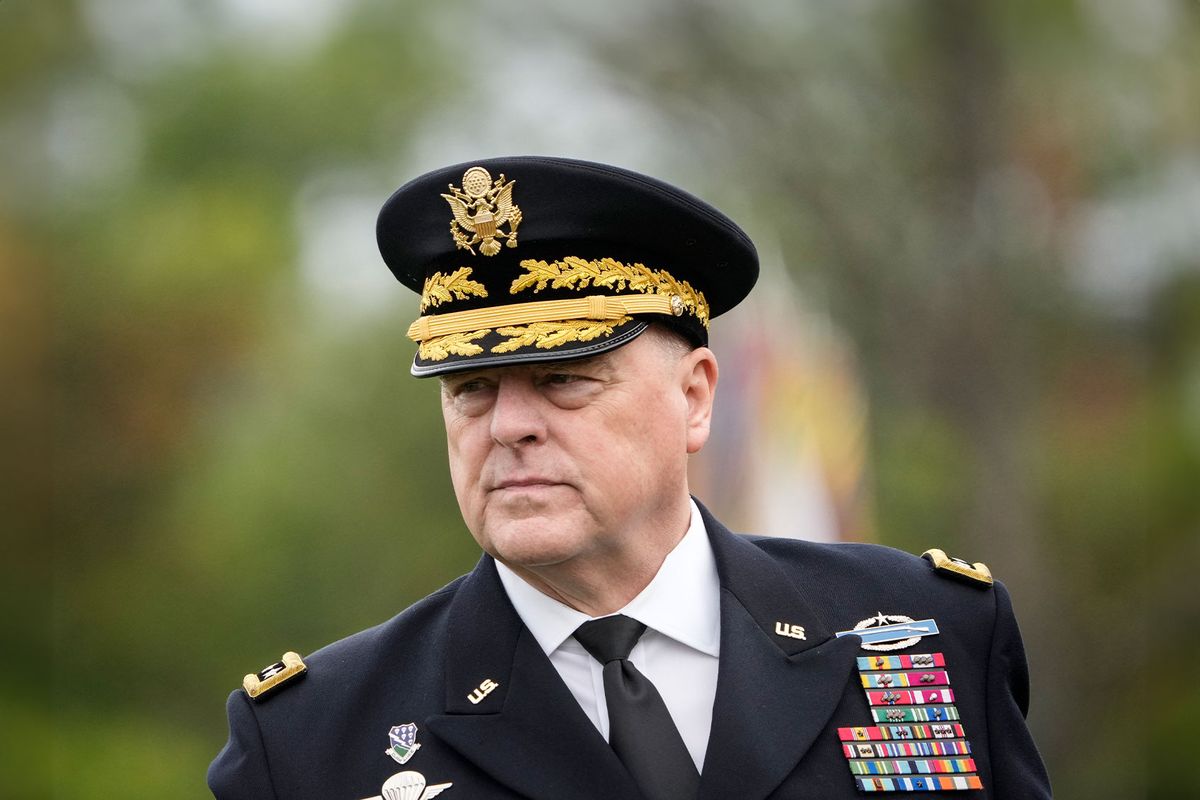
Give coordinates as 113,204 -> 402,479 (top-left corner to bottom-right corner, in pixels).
575,615 -> 700,800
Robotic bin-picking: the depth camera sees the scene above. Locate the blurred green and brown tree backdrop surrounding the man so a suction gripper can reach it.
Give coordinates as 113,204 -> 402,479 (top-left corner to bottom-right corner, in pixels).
0,0 -> 1200,800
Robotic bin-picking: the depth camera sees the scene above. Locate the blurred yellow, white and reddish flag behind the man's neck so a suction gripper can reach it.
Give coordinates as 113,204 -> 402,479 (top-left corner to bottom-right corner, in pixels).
689,266 -> 872,541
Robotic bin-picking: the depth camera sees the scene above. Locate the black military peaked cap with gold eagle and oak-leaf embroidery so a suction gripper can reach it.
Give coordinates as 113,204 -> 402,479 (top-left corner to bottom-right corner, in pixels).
376,156 -> 758,377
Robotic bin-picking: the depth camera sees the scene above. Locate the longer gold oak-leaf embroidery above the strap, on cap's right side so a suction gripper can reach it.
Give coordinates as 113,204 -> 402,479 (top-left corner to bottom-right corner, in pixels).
509,255 -> 708,327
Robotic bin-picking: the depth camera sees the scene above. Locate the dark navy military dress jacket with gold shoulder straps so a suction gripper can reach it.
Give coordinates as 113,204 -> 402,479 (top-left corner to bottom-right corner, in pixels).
209,510 -> 1050,800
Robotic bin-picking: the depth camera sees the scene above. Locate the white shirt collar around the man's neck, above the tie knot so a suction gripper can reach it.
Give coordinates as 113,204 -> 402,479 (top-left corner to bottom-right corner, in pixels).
496,501 -> 721,656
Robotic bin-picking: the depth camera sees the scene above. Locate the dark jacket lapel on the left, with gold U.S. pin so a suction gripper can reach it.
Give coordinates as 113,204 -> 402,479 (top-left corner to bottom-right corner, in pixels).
427,557 -> 638,800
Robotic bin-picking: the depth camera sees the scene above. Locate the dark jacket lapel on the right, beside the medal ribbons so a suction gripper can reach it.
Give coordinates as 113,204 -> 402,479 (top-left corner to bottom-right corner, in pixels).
700,506 -> 858,800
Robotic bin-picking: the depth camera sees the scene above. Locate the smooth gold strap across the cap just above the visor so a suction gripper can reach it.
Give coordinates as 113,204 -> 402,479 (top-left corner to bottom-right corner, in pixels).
408,294 -> 707,342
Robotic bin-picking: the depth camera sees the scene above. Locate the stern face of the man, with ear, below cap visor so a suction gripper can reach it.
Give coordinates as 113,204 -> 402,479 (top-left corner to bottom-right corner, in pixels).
442,329 -> 716,569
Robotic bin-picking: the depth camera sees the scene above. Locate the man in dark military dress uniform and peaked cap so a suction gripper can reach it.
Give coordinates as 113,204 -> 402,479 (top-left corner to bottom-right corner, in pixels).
209,157 -> 1050,800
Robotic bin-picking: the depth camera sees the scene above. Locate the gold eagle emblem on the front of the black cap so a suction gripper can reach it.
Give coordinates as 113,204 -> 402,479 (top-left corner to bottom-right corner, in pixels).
442,167 -> 521,255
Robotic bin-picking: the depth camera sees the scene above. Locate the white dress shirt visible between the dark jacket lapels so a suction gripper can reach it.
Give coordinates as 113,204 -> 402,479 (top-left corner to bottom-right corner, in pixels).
496,503 -> 721,770
